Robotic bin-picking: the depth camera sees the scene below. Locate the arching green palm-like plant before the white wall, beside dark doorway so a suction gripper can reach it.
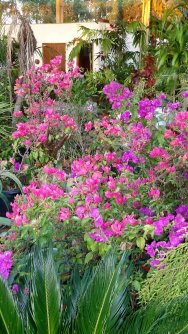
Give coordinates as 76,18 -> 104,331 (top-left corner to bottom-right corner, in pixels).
70,21 -> 146,82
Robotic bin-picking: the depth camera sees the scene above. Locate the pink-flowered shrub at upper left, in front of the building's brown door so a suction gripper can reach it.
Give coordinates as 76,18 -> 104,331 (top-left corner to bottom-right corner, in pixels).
12,56 -> 81,163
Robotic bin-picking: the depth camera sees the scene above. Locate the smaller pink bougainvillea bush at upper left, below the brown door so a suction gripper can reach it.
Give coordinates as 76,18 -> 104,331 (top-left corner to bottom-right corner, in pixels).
12,56 -> 97,166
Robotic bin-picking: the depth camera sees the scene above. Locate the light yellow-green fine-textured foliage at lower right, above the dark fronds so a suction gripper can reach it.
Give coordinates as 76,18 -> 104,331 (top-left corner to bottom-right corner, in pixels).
139,243 -> 188,304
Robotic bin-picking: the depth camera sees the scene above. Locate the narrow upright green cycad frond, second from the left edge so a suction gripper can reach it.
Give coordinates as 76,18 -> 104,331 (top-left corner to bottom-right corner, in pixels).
31,249 -> 61,334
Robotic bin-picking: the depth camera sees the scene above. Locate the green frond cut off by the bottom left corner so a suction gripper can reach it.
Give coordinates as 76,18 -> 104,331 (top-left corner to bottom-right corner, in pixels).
0,275 -> 24,334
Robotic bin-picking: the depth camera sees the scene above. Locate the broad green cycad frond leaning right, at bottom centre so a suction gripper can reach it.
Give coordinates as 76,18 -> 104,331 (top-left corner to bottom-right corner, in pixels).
75,253 -> 131,334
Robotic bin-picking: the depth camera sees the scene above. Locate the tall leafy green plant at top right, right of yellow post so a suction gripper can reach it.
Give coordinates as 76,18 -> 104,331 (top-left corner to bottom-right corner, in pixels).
151,10 -> 188,97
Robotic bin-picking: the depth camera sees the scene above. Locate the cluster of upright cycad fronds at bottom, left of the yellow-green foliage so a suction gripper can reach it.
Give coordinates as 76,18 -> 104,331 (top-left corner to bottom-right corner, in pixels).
0,248 -> 131,334
